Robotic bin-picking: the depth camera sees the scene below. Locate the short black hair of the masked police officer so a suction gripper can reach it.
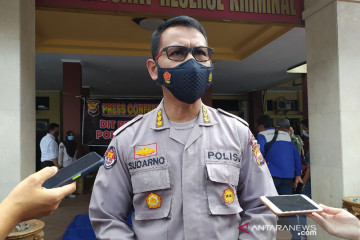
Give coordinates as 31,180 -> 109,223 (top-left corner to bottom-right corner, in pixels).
151,16 -> 207,59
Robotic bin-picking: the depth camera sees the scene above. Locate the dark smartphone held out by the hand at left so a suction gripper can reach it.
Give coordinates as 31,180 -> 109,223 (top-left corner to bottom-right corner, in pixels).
42,152 -> 105,188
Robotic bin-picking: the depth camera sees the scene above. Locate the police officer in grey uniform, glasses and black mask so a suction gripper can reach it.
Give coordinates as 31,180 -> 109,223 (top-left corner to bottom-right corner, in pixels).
89,16 -> 277,240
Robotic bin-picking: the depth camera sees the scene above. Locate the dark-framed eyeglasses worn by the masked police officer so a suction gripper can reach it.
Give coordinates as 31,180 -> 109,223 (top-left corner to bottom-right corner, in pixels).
155,46 -> 214,62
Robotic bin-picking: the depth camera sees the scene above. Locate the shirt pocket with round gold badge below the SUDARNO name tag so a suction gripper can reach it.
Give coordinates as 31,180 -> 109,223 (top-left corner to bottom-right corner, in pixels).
131,169 -> 172,220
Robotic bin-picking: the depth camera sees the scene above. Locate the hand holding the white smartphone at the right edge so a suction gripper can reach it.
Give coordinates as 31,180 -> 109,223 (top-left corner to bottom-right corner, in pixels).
307,204 -> 360,240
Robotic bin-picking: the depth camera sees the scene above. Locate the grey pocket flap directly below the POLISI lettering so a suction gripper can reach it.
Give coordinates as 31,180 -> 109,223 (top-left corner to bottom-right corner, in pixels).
206,163 -> 240,186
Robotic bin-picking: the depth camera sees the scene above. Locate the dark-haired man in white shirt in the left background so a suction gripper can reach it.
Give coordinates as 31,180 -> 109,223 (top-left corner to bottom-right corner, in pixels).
40,123 -> 61,168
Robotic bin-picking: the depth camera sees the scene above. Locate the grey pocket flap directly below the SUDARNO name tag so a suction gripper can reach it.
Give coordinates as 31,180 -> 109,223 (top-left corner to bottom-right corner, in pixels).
131,169 -> 170,193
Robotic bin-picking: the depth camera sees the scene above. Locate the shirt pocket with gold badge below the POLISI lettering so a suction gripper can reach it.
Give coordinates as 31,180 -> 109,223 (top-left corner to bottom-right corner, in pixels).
206,163 -> 242,215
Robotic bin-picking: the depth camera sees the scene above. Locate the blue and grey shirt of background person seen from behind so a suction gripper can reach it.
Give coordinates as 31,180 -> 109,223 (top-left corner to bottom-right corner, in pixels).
257,128 -> 301,178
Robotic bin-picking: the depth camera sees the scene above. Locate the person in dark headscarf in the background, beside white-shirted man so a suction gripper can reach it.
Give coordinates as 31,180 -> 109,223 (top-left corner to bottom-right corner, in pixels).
59,131 -> 78,198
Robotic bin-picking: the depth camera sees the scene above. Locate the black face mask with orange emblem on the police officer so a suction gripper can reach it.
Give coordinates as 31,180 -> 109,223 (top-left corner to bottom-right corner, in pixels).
157,59 -> 214,104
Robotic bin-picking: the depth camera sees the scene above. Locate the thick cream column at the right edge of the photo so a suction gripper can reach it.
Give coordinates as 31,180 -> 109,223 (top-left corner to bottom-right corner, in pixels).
303,0 -> 360,239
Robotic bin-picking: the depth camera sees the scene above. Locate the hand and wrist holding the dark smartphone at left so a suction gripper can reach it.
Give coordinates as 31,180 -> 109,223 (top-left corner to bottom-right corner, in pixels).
0,167 -> 76,240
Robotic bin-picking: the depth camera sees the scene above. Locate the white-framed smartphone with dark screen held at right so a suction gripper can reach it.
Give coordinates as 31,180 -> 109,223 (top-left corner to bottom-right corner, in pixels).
260,194 -> 323,216
